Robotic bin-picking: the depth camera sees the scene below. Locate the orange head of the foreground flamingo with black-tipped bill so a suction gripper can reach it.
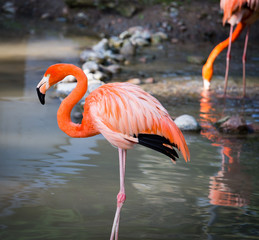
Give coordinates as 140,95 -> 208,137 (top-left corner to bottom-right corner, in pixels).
37,64 -> 76,105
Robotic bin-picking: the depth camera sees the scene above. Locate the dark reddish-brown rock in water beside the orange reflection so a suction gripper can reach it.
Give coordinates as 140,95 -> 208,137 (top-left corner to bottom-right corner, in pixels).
218,115 -> 253,134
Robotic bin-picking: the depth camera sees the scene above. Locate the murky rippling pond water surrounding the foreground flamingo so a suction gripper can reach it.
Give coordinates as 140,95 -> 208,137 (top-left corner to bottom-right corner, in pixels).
0,24 -> 259,240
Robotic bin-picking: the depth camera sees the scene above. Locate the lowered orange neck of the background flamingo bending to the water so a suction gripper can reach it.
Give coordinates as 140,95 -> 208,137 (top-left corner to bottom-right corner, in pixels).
203,22 -> 246,80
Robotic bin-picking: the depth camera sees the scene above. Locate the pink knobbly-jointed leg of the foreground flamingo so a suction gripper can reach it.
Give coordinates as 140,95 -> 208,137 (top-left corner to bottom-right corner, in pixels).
110,148 -> 127,240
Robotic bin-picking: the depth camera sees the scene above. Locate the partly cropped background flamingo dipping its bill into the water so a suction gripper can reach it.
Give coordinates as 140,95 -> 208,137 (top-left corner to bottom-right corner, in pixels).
202,0 -> 259,96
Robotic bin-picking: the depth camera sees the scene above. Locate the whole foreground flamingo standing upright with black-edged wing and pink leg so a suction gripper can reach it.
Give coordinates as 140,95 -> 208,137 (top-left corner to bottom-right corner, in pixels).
37,64 -> 190,239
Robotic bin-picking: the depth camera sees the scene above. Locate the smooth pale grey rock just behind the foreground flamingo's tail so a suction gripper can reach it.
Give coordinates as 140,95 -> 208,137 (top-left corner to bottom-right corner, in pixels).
174,114 -> 201,131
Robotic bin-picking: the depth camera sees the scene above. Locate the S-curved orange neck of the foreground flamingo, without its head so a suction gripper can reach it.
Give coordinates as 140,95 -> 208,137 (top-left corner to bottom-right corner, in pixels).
57,65 -> 88,137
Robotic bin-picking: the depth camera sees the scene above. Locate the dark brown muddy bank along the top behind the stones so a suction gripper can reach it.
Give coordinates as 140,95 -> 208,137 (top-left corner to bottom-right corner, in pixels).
0,0 -> 259,44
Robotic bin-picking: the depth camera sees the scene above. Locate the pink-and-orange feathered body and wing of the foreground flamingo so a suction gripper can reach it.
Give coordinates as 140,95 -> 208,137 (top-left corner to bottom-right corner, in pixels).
88,83 -> 189,160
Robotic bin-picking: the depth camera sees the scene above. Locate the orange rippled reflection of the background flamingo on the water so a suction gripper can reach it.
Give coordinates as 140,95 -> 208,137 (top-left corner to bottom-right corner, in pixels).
200,90 -> 251,207
